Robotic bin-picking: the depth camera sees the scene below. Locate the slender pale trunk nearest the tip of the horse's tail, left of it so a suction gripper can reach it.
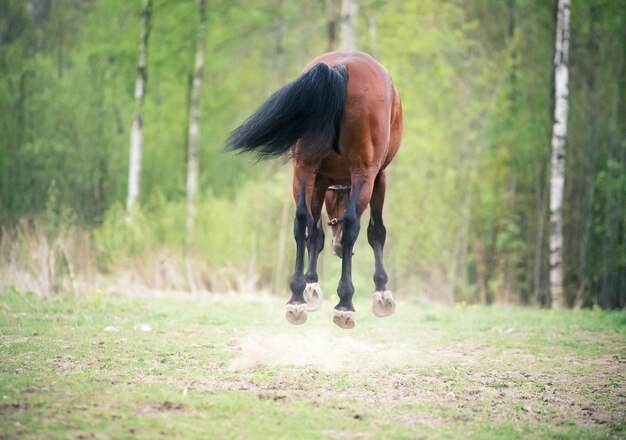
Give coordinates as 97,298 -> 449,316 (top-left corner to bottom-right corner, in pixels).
185,0 -> 207,292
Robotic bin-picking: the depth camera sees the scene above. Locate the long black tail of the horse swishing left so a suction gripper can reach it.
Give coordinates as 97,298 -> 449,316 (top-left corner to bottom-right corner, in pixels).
226,63 -> 348,159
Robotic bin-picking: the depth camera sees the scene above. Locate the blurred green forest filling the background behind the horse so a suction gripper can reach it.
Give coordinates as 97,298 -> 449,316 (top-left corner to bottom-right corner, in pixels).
0,0 -> 626,308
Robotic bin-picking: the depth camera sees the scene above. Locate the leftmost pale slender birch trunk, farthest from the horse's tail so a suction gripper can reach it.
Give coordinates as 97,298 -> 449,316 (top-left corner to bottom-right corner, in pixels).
126,0 -> 152,215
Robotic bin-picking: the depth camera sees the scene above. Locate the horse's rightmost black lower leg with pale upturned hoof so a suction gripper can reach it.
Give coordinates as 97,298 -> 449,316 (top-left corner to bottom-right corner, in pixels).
367,171 -> 396,317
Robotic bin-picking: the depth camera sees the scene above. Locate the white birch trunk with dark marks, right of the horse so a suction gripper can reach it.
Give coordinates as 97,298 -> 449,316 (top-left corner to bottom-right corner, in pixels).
550,0 -> 570,308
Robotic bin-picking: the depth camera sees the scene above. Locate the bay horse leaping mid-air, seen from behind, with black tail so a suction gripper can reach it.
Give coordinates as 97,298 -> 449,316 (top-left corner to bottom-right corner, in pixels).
225,52 -> 402,329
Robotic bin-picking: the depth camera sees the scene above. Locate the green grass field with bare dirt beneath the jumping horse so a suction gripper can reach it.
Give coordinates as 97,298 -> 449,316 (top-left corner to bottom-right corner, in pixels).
0,290 -> 626,439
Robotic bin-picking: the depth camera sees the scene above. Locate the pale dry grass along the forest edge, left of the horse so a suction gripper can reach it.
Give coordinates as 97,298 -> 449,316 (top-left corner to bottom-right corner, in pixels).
0,219 -> 258,296
